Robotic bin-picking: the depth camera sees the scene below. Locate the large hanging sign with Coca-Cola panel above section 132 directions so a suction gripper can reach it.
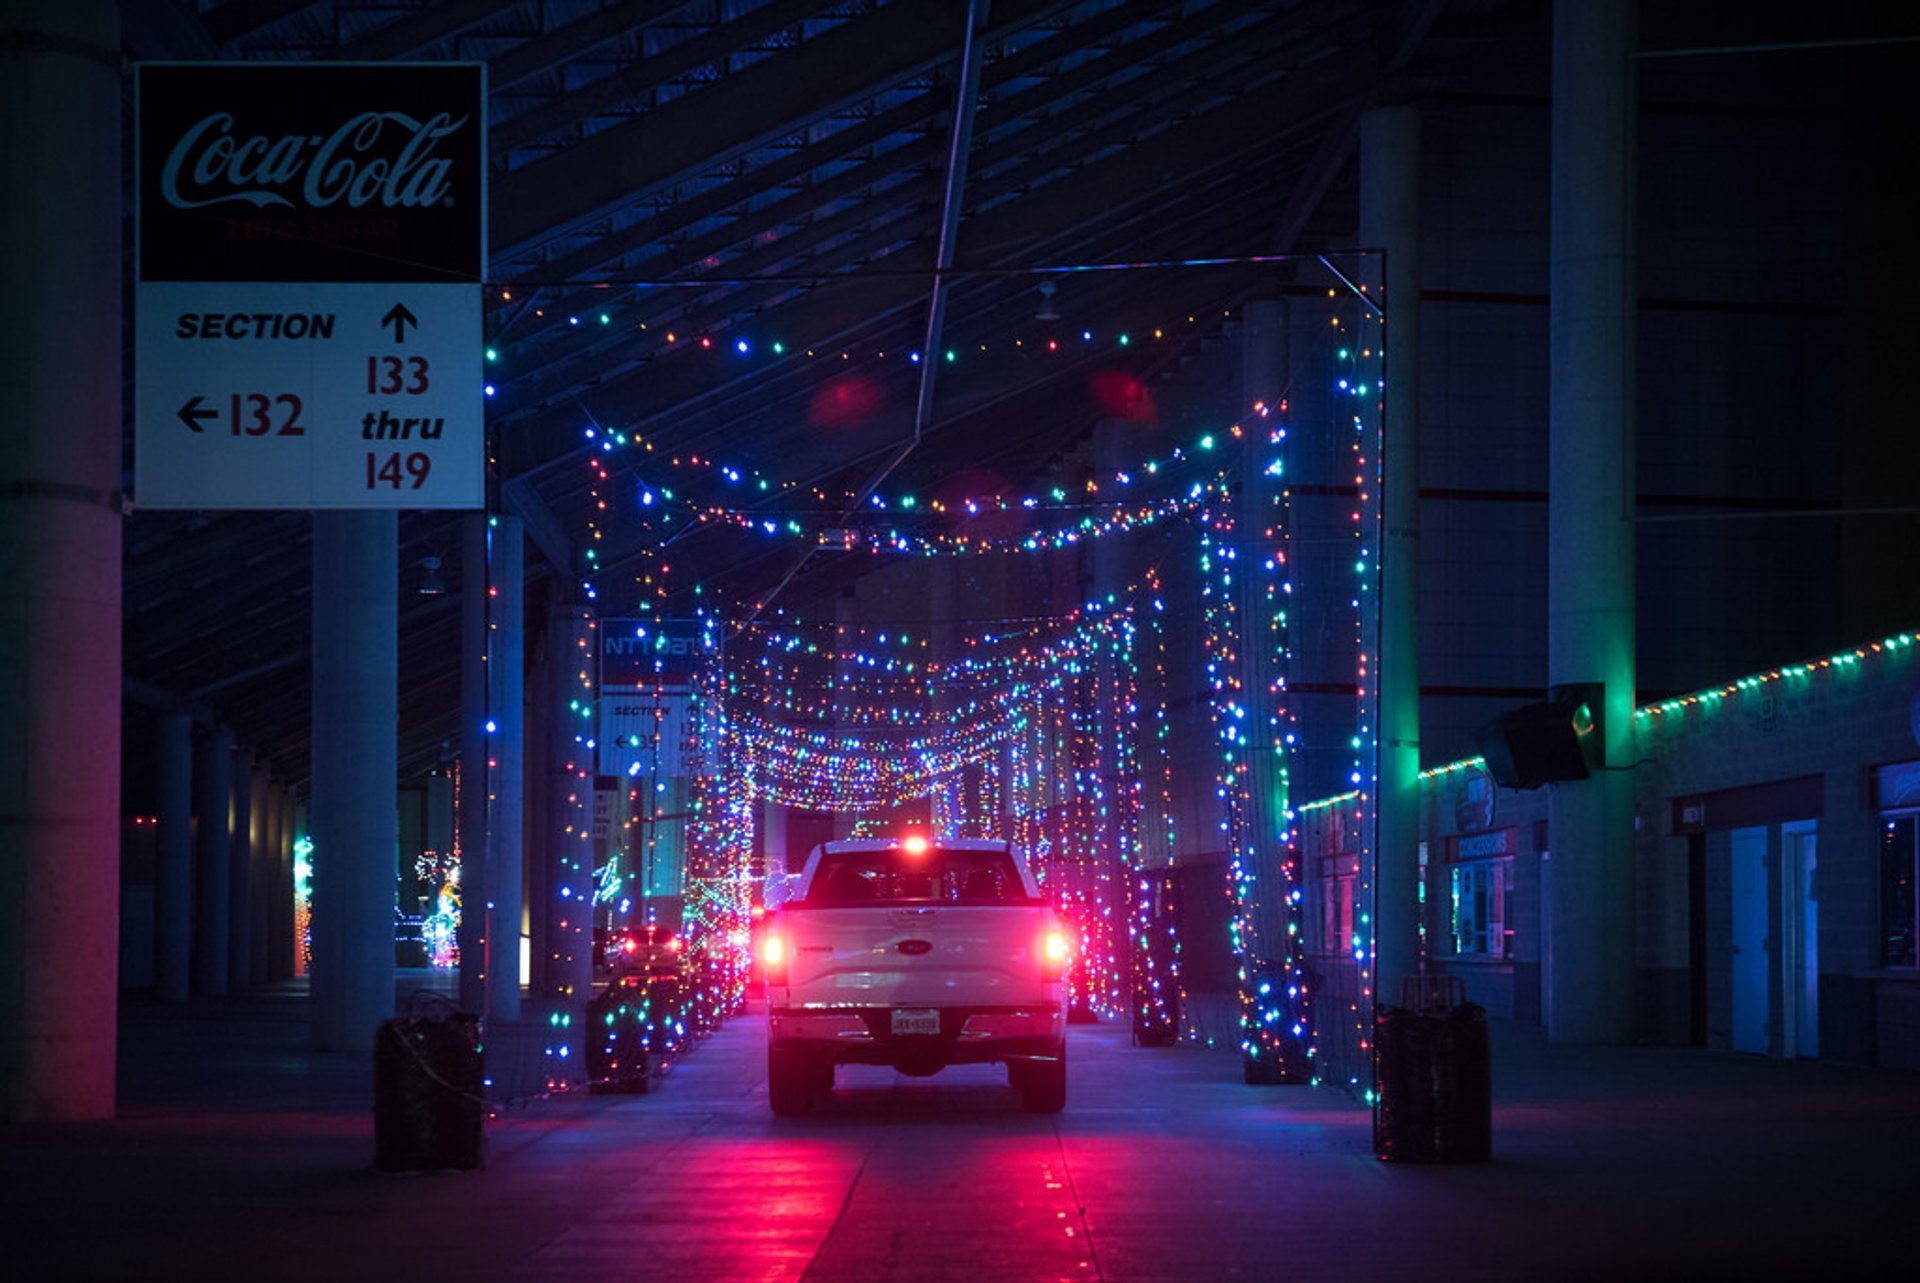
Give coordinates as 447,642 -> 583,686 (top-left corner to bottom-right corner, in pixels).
134,63 -> 486,509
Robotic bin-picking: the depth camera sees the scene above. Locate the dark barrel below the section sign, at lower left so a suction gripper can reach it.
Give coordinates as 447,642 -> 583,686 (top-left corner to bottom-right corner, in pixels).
372,1006 -> 486,1172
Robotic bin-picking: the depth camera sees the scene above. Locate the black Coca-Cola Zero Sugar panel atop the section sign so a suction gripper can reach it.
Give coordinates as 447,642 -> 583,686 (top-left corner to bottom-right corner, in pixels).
136,63 -> 486,282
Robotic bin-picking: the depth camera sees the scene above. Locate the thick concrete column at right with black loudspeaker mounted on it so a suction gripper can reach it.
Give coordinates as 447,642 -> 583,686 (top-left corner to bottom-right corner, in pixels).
1542,0 -> 1636,1043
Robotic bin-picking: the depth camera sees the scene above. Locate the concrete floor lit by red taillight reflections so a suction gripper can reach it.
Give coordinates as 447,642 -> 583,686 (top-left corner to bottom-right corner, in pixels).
0,985 -> 1920,1283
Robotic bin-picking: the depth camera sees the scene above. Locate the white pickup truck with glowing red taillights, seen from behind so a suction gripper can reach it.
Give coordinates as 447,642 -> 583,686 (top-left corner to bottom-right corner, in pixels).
760,835 -> 1069,1114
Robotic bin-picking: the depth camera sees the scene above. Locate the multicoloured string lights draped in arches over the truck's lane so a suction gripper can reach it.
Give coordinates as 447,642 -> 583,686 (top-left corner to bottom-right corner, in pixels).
526,276 -> 1379,1090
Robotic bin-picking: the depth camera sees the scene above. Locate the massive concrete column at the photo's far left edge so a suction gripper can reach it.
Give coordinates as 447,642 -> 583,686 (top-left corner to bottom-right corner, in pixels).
0,0 -> 123,1122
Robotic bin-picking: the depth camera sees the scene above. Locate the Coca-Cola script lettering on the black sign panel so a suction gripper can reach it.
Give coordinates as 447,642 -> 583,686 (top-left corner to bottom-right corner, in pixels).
159,111 -> 468,209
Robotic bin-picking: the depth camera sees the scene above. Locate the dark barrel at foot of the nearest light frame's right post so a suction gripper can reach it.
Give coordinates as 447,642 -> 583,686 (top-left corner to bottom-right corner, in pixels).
1373,1003 -> 1494,1162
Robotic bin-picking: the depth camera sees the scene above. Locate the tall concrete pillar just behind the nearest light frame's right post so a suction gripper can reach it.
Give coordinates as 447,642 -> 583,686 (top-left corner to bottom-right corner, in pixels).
1359,108 -> 1421,1003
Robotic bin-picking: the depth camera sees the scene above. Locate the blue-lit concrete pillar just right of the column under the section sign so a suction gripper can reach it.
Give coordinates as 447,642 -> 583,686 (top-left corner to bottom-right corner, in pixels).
461,517 -> 526,1022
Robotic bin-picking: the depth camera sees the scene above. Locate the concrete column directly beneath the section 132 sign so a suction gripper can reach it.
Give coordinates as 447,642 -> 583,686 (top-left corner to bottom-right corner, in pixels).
311,511 -> 399,1051
